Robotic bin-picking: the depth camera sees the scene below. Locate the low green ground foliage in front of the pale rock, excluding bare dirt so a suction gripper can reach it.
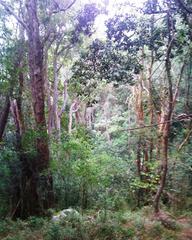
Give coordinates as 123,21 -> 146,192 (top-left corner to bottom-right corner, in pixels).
0,211 -> 188,240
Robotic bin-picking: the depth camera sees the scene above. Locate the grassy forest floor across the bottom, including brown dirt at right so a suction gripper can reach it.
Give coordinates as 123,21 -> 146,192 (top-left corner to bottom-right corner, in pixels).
0,208 -> 192,240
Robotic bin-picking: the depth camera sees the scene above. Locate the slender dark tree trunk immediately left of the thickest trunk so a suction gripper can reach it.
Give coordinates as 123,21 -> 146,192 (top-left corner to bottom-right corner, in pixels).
11,34 -> 26,218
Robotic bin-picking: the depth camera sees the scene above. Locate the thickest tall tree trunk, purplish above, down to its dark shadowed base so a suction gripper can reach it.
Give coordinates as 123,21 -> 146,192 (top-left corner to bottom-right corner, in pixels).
15,0 -> 53,217
